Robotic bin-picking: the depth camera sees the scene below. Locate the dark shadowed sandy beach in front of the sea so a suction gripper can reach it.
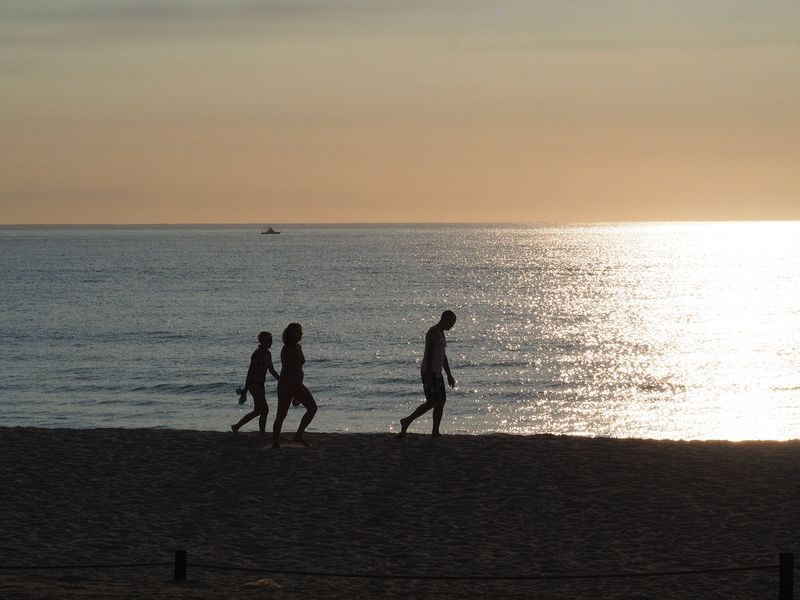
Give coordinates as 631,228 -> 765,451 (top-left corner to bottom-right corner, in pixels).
0,428 -> 800,598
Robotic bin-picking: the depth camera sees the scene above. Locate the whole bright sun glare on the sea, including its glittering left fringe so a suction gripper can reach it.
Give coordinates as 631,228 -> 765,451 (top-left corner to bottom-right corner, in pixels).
482,222 -> 800,440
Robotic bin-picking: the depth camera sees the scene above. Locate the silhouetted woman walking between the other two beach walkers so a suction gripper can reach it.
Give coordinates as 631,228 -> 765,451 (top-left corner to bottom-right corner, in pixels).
272,323 -> 317,448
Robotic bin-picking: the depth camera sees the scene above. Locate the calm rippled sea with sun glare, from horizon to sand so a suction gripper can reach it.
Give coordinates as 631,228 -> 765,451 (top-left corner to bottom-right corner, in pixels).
0,223 -> 800,440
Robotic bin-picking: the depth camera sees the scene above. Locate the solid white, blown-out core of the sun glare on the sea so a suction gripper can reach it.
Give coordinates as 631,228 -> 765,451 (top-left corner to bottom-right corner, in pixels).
646,223 -> 800,440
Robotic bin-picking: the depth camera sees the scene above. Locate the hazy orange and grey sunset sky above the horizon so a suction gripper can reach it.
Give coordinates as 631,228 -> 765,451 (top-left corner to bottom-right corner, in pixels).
0,0 -> 800,225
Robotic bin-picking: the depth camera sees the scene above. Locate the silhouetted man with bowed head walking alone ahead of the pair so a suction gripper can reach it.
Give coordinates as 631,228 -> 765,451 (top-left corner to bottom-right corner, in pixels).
400,310 -> 456,436
